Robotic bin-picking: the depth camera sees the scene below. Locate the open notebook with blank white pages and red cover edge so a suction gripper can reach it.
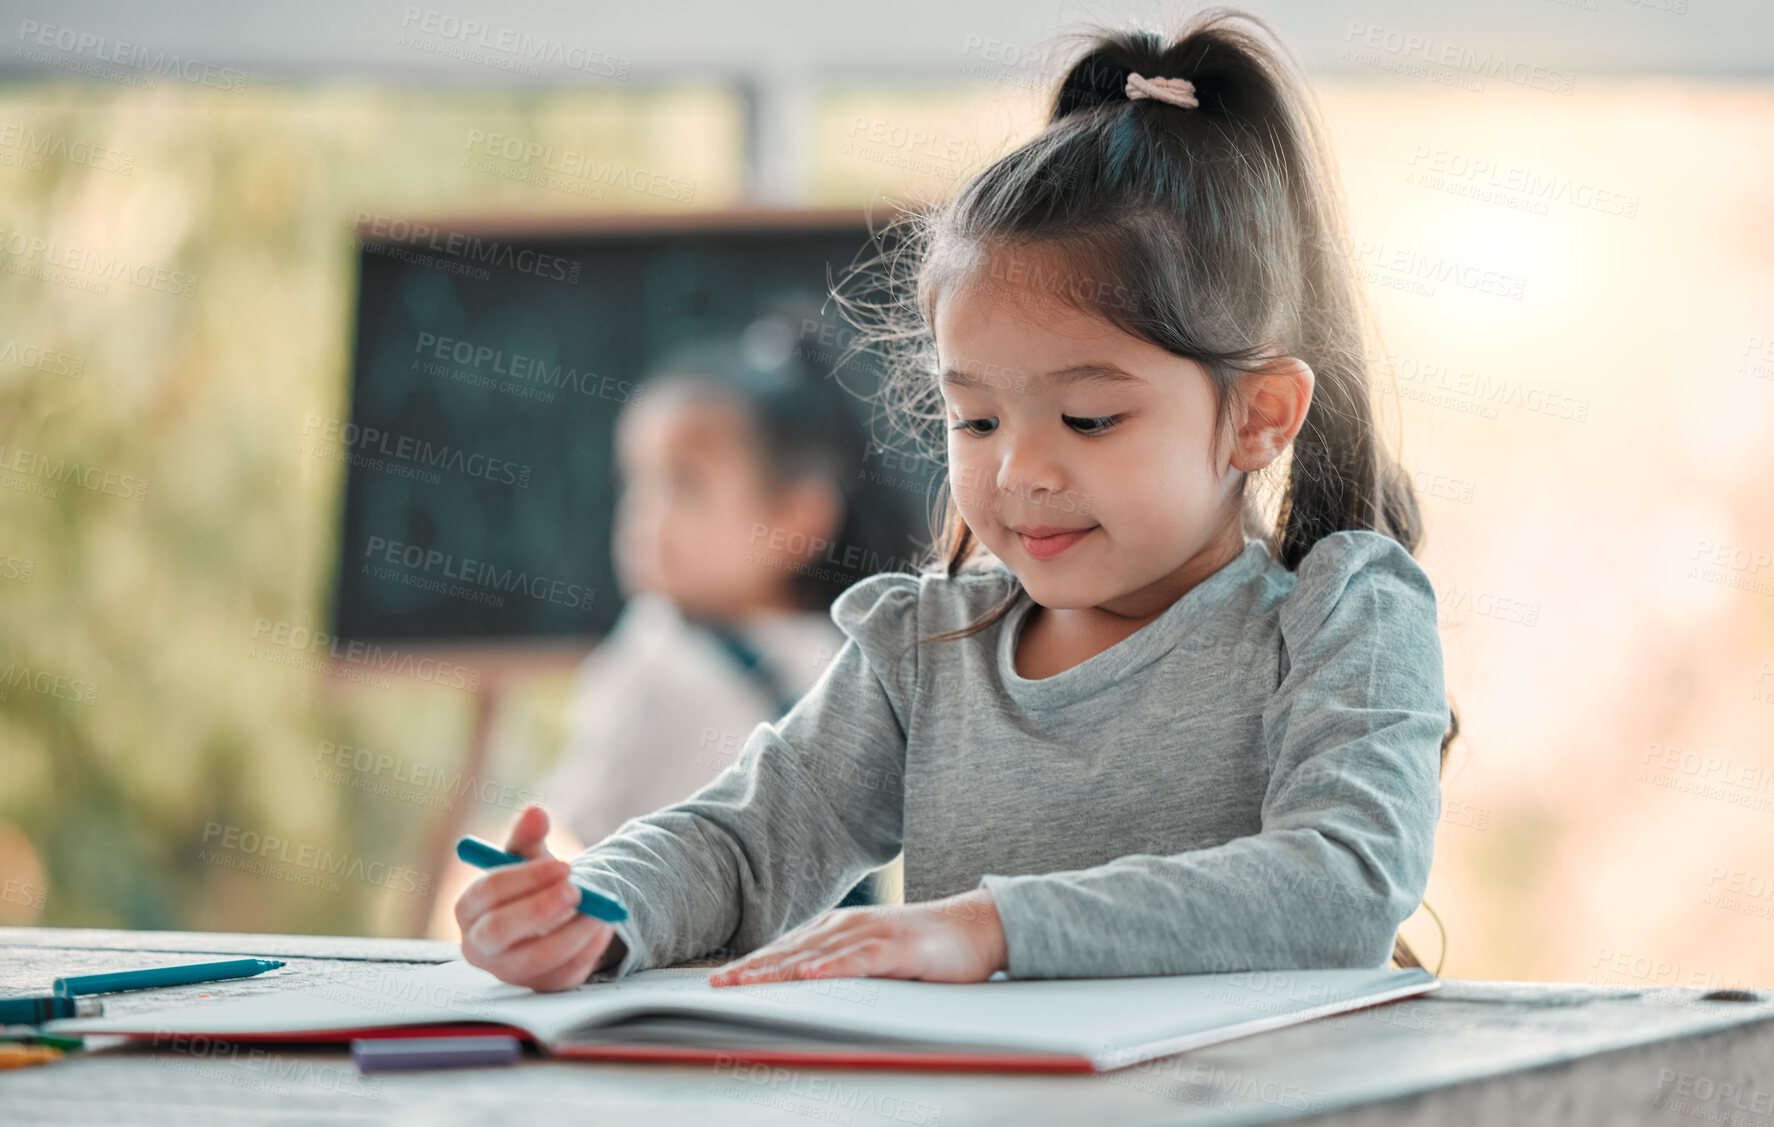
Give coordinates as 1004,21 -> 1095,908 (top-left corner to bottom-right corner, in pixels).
48,962 -> 1440,1072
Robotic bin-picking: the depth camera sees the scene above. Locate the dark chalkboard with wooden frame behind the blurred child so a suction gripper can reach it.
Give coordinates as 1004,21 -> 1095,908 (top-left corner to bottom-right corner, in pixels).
331,213 -> 935,644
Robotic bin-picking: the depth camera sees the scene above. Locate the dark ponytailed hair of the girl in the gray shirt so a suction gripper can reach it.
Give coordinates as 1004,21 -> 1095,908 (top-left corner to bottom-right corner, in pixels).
834,7 -> 1460,767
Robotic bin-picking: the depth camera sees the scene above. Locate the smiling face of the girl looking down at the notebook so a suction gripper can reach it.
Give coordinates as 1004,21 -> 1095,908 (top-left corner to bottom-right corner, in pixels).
933,252 -> 1311,618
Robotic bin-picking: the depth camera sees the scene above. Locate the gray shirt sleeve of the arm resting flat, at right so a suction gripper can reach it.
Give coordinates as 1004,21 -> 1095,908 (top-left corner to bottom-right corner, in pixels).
979,531 -> 1449,978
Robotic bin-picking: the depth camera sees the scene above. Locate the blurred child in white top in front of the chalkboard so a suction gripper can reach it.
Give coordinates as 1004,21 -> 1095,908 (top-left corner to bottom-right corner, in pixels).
541,318 -> 914,905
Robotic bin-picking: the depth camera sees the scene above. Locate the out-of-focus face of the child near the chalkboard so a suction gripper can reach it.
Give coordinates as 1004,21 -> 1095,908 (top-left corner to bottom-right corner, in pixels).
614,396 -> 837,619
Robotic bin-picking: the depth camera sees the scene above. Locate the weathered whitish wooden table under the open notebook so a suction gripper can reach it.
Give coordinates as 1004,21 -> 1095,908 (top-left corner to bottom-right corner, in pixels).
0,928 -> 1774,1127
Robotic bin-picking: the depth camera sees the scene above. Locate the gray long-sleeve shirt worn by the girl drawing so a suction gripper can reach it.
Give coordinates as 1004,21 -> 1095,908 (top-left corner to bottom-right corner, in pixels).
573,531 -> 1449,978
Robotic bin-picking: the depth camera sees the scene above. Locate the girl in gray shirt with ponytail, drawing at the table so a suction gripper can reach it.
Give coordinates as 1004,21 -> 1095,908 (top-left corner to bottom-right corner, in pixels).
456,11 -> 1456,990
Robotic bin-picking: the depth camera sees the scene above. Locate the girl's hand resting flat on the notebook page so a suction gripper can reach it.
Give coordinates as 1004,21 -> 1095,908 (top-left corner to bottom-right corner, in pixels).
708,889 -> 1009,987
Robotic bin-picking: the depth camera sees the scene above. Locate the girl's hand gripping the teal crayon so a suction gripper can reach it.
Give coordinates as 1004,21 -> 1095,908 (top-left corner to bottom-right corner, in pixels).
456,806 -> 626,990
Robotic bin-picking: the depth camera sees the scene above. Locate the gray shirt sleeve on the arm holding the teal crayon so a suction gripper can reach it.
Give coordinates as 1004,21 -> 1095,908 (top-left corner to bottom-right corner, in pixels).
573,571 -> 921,978
